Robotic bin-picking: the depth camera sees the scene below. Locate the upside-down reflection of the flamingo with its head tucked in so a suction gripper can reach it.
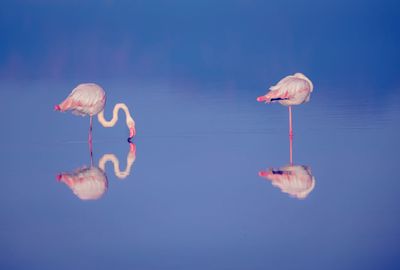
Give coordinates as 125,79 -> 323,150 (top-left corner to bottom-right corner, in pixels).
258,137 -> 315,199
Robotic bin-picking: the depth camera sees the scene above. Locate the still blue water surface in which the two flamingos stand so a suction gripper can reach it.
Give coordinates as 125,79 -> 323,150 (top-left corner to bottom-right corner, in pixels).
0,78 -> 400,269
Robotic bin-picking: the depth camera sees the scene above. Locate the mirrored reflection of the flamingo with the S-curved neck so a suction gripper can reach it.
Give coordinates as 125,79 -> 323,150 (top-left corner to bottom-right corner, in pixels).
57,143 -> 136,200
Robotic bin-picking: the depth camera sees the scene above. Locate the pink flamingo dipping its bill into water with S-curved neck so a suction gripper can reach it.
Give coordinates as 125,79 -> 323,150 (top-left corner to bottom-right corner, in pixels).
54,83 -> 136,142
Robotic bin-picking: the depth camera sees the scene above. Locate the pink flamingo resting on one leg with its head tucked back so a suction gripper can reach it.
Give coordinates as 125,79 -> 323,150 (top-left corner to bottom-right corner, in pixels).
257,73 -> 314,137
